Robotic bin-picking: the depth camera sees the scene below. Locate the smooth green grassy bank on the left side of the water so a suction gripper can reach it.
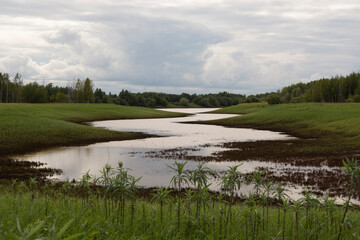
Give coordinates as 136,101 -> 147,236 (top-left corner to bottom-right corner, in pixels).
0,104 -> 183,156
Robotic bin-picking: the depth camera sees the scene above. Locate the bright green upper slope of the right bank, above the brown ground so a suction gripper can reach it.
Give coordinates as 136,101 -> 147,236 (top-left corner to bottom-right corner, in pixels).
210,103 -> 360,140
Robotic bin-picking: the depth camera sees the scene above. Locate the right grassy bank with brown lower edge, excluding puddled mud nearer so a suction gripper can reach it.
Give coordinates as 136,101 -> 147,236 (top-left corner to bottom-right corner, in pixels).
204,103 -> 360,166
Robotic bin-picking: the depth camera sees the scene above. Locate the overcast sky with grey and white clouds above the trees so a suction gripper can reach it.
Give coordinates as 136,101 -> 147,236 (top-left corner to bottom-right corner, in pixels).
0,0 -> 360,95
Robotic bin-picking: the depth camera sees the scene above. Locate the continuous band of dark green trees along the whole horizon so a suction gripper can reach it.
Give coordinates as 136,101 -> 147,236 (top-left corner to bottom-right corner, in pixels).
0,72 -> 360,108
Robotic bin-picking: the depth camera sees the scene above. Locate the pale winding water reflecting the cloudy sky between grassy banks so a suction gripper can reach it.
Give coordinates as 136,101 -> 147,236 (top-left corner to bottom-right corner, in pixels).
21,109 -> 330,198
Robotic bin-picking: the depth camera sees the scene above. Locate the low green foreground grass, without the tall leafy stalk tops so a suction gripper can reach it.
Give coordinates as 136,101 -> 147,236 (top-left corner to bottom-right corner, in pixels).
0,167 -> 360,239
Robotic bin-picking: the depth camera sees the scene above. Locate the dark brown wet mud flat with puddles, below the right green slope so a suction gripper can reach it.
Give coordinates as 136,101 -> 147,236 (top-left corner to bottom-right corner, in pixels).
146,139 -> 360,199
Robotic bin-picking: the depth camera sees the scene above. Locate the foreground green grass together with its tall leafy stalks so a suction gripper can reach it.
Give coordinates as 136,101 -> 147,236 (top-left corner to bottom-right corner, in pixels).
0,160 -> 360,239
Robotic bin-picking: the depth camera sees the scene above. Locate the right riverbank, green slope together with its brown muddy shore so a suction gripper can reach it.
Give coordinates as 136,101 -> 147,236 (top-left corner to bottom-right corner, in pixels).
174,103 -> 360,196
